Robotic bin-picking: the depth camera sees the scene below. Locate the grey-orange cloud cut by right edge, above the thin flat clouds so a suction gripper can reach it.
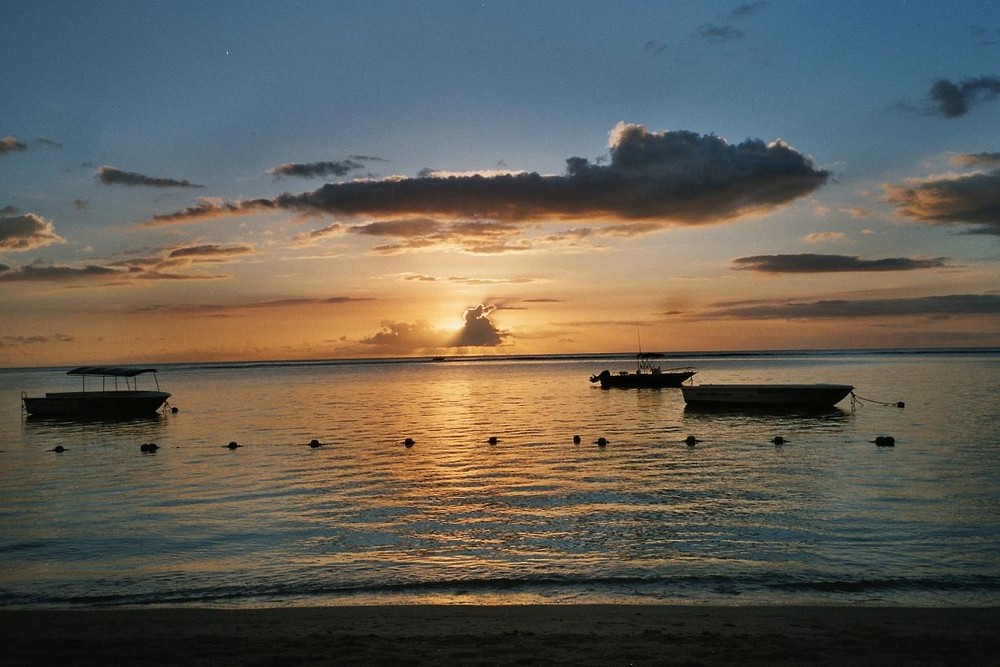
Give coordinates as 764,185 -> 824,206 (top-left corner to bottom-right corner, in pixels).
882,169 -> 1000,235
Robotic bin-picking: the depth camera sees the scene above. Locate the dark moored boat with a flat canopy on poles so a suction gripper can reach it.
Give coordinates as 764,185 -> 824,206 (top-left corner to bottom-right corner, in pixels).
21,366 -> 170,419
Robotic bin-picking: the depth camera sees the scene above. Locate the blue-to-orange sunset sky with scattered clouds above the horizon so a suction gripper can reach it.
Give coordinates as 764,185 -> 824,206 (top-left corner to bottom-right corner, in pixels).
0,0 -> 1000,367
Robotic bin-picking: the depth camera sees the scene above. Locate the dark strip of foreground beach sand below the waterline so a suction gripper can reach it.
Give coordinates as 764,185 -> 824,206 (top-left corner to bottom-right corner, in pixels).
0,605 -> 1000,667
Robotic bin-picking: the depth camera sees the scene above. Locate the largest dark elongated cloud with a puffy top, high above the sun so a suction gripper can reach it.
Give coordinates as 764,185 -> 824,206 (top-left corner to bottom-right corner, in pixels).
146,123 -> 829,235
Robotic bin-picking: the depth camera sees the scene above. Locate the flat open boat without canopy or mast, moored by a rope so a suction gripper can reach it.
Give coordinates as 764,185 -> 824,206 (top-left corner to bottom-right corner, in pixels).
681,383 -> 854,410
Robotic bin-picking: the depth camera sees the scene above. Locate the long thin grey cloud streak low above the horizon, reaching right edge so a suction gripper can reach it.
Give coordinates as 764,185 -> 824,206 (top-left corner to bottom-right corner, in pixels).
703,294 -> 1000,320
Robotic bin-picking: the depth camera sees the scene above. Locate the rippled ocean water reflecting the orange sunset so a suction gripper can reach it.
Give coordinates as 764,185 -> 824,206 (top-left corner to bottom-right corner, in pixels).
0,350 -> 1000,607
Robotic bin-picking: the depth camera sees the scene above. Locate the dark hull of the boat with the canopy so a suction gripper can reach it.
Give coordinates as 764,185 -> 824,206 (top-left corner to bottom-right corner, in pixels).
22,391 -> 170,419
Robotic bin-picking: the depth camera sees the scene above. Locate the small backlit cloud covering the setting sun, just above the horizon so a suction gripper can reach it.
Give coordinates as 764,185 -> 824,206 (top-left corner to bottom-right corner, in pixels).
361,304 -> 509,352
